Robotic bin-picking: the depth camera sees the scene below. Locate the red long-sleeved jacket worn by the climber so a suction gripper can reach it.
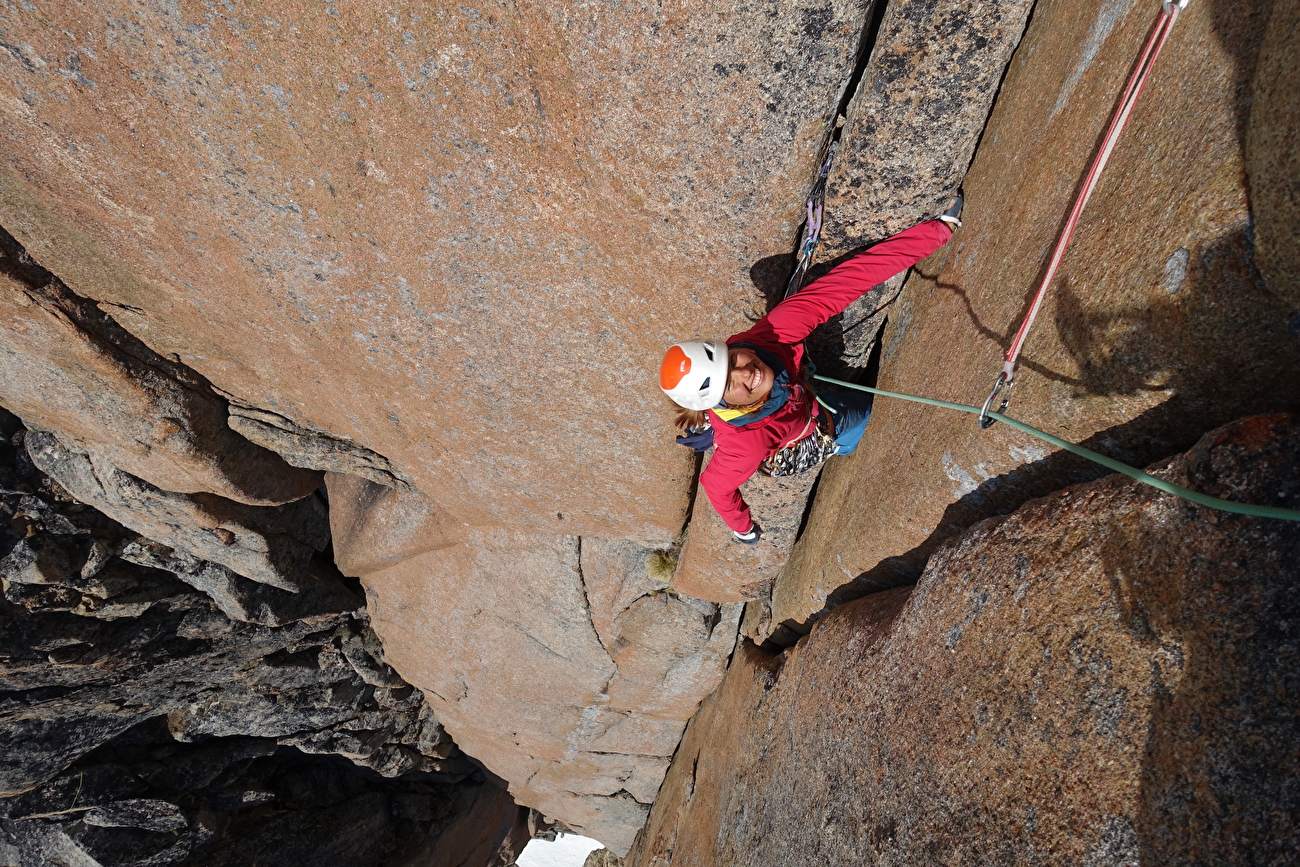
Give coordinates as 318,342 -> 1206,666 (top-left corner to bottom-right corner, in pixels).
699,220 -> 953,533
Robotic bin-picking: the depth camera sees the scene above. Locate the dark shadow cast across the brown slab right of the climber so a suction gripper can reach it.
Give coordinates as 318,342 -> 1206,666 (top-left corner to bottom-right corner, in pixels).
771,224 -> 1300,643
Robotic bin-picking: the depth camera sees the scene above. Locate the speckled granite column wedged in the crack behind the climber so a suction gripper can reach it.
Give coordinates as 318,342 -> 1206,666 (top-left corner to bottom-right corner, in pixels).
675,0 -> 1034,601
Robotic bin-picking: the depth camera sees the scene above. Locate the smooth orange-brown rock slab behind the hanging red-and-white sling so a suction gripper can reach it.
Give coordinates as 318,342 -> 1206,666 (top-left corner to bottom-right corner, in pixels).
751,0 -> 1300,638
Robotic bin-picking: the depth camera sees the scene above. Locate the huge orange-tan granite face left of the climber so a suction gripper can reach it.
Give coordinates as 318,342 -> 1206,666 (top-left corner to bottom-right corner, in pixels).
0,0 -> 899,849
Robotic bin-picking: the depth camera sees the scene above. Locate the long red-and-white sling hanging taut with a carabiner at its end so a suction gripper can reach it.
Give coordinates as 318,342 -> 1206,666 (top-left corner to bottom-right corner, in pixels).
979,0 -> 1187,428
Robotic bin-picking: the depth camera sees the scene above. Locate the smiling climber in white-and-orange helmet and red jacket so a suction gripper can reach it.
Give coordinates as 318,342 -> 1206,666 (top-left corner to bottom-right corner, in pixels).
659,195 -> 962,545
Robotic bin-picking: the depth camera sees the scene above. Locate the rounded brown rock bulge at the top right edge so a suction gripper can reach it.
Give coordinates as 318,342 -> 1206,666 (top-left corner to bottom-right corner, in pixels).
1245,3 -> 1300,311
